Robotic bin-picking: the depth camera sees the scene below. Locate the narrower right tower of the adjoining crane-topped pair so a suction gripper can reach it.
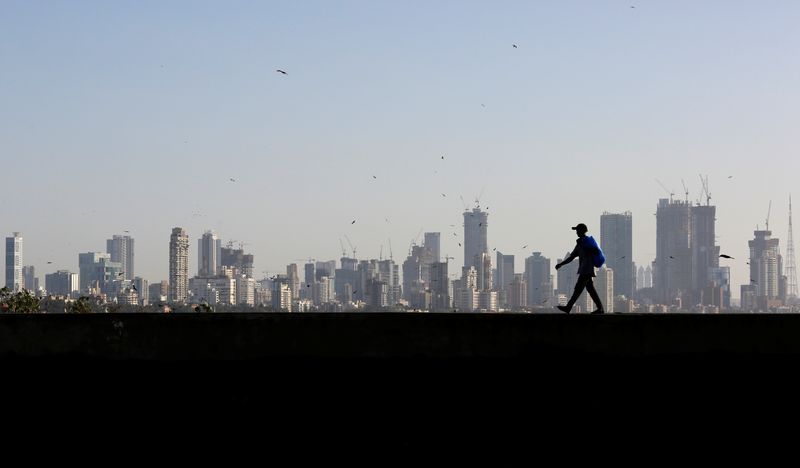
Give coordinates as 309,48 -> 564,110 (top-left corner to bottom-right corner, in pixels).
691,205 -> 719,303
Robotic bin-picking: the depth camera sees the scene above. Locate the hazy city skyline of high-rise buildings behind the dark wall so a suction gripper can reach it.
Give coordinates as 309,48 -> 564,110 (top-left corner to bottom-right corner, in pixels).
5,188 -> 798,313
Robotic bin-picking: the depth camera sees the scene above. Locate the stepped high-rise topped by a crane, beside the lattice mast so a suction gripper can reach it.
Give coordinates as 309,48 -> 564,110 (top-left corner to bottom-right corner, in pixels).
748,230 -> 783,308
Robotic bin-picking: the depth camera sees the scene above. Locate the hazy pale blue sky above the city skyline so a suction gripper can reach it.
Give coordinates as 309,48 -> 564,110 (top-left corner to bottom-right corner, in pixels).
0,0 -> 800,296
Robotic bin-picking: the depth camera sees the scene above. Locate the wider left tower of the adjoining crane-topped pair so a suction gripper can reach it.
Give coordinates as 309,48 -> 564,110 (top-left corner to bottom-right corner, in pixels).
653,198 -> 692,304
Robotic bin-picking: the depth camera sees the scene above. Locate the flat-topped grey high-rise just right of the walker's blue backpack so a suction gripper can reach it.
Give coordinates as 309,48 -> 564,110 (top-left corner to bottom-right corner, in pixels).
600,211 -> 636,297
